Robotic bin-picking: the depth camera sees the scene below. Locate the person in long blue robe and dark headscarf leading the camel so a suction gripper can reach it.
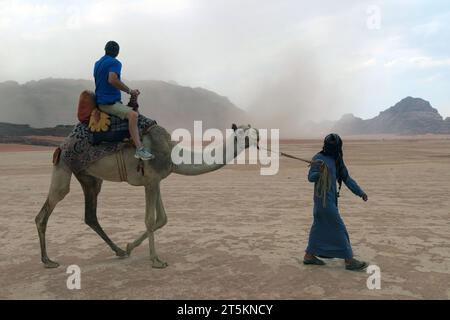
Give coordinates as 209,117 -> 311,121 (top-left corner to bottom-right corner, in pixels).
303,133 -> 368,271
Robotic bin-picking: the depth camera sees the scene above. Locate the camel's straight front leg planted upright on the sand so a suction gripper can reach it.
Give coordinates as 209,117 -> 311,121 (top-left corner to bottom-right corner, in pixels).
145,185 -> 167,268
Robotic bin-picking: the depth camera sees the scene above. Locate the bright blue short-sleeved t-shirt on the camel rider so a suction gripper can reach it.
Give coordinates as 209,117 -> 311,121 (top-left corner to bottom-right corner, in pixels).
94,55 -> 122,104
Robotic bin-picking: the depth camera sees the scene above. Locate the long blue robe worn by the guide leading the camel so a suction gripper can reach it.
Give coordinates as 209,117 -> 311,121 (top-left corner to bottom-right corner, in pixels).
306,153 -> 364,259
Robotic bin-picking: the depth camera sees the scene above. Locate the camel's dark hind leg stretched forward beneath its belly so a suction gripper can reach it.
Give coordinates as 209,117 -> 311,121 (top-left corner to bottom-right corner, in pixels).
76,174 -> 127,257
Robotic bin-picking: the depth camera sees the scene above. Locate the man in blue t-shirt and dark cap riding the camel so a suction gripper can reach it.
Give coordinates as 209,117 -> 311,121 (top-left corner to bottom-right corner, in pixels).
94,41 -> 155,160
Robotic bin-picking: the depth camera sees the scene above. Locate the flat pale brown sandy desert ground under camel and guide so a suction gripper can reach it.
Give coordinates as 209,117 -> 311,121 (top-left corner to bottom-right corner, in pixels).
0,137 -> 450,299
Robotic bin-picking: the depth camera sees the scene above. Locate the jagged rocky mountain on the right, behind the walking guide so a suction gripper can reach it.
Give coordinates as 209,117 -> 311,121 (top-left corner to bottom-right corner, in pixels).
332,97 -> 450,135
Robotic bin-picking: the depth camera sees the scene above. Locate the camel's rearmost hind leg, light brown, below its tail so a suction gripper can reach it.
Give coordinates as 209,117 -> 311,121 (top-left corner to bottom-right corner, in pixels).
35,161 -> 72,268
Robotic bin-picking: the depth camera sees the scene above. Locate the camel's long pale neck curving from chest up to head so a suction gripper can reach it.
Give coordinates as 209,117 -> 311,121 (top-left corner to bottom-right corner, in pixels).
172,136 -> 245,176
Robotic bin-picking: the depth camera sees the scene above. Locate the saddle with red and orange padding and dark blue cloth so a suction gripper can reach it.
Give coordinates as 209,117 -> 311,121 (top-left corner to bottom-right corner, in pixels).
78,90 -> 139,144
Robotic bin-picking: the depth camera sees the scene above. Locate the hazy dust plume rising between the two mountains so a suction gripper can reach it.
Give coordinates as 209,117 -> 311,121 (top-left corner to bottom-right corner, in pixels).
247,48 -> 354,138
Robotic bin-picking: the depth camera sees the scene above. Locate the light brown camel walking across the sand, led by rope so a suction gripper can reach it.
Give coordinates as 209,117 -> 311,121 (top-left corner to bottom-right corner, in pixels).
35,124 -> 259,268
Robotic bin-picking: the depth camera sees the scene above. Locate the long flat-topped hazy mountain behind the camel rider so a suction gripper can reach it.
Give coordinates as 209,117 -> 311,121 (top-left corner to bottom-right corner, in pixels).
0,78 -> 247,130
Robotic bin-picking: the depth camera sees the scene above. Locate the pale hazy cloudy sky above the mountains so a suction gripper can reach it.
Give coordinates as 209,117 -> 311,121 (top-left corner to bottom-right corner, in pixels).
0,0 -> 450,121
